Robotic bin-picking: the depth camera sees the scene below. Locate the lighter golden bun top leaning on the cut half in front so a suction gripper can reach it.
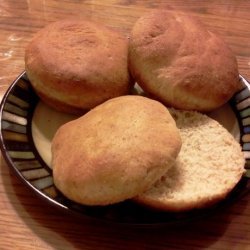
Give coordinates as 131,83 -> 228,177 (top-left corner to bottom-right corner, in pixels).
52,96 -> 181,205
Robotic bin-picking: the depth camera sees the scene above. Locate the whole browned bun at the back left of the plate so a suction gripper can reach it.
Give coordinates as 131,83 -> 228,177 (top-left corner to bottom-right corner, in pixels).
25,19 -> 132,114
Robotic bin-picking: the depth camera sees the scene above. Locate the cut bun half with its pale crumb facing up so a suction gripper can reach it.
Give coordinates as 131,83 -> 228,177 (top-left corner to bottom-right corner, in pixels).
135,109 -> 245,212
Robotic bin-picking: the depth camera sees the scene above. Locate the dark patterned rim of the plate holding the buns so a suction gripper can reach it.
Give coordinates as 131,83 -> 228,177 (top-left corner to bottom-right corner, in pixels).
0,72 -> 250,226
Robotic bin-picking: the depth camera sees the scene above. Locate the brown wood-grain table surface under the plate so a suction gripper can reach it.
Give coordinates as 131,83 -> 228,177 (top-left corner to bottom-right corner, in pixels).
0,0 -> 250,250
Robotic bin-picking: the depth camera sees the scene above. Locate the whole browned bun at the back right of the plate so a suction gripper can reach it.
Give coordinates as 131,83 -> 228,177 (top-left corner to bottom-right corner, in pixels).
128,9 -> 240,112
